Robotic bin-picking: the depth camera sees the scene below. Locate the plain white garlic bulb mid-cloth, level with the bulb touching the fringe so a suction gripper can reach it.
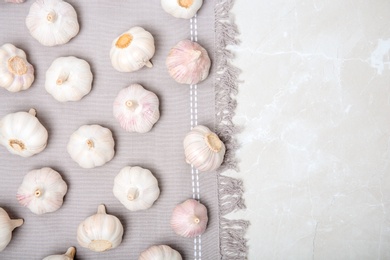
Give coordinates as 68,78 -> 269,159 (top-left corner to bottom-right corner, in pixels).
67,125 -> 115,168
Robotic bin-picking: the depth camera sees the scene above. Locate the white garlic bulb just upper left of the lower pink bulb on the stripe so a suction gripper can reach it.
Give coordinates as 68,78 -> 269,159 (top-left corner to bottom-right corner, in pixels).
113,166 -> 160,211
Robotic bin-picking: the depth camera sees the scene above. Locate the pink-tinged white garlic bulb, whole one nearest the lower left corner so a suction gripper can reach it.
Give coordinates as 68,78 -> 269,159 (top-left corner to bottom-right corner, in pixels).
16,167 -> 68,215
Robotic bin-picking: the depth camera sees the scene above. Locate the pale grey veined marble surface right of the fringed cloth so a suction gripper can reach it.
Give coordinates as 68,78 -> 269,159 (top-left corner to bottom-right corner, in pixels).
227,0 -> 390,259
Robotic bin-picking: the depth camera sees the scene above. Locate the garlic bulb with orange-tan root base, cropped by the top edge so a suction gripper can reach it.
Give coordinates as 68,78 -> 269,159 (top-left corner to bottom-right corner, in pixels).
161,0 -> 203,19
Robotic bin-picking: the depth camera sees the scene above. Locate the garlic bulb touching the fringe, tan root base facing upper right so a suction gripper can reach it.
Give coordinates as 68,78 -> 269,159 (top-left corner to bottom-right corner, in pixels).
183,125 -> 226,172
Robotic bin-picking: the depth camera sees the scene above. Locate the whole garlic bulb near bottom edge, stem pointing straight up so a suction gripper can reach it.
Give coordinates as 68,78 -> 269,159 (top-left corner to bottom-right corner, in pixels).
77,205 -> 123,252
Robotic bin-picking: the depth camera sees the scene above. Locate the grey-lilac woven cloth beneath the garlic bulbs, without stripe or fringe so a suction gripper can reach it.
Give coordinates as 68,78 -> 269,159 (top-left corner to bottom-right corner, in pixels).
0,0 -> 219,259
